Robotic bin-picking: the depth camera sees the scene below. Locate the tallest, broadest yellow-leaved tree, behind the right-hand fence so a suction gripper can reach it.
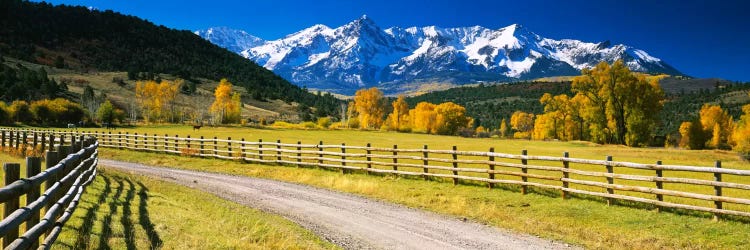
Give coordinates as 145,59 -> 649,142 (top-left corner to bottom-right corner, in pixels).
572,60 -> 664,146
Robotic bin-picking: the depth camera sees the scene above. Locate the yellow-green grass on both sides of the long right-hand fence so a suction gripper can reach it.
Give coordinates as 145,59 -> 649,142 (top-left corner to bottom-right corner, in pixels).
81,126 -> 750,249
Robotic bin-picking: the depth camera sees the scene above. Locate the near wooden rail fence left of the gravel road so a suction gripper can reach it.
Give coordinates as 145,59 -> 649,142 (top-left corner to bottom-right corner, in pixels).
0,129 -> 99,249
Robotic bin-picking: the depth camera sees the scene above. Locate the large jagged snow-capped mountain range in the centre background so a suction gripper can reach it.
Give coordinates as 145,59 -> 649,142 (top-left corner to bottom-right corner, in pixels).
196,16 -> 682,94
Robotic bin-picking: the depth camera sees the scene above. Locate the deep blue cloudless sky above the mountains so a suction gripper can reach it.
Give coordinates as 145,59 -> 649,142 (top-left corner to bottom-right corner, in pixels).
38,0 -> 750,81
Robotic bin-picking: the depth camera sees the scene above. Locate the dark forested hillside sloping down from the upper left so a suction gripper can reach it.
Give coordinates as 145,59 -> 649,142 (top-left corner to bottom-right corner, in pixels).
0,0 -> 337,117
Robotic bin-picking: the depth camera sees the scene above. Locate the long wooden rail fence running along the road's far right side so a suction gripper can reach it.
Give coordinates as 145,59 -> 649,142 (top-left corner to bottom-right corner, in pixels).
1,131 -> 750,219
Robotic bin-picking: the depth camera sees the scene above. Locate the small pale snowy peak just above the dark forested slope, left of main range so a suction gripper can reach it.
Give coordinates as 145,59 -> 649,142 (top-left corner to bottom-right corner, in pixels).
193,27 -> 266,53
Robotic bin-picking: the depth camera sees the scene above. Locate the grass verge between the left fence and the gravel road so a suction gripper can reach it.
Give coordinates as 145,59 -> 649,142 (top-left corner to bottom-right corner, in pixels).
0,150 -> 337,249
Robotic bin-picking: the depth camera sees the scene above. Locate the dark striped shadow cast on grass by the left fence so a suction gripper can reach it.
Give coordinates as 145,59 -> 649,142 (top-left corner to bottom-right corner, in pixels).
66,174 -> 162,249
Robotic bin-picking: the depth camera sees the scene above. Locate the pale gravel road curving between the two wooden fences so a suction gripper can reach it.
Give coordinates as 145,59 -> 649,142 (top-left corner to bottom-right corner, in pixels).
99,159 -> 570,249
